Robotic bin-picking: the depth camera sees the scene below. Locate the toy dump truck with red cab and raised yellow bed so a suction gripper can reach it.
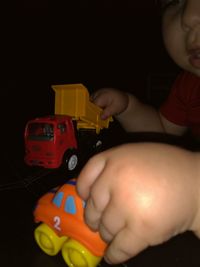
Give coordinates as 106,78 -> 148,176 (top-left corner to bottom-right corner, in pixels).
25,84 -> 112,170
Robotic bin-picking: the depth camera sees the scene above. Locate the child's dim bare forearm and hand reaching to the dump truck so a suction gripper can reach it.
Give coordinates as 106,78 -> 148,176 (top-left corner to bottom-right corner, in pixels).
91,88 -> 186,135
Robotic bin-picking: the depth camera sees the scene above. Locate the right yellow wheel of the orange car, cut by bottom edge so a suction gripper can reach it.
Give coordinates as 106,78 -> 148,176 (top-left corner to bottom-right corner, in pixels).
62,239 -> 101,267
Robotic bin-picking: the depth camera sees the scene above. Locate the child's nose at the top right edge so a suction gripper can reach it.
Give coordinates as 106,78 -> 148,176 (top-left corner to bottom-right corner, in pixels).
182,0 -> 200,31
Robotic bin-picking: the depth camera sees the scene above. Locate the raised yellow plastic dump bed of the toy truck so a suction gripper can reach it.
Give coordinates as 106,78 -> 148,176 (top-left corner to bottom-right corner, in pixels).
52,84 -> 112,133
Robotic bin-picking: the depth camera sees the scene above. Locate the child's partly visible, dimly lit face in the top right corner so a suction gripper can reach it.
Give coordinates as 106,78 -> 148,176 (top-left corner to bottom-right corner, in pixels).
161,0 -> 200,77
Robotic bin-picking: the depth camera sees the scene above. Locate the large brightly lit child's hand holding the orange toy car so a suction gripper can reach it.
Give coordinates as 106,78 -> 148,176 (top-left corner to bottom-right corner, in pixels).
77,143 -> 200,264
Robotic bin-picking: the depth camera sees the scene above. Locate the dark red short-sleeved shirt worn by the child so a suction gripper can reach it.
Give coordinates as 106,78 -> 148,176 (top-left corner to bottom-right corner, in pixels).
160,71 -> 200,136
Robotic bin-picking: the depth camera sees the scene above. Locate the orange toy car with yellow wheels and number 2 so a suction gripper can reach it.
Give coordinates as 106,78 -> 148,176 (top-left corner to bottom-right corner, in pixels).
34,179 -> 107,267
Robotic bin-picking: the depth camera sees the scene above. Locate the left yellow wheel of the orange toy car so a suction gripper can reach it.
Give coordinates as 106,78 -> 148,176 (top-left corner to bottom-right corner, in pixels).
34,223 -> 67,256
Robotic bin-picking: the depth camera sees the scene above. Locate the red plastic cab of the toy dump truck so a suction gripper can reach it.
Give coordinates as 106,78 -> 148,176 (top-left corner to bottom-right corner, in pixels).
25,115 -> 77,169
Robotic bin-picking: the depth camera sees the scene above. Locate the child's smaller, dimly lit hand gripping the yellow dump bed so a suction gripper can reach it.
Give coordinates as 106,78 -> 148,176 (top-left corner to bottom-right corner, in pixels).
91,88 -> 128,119
